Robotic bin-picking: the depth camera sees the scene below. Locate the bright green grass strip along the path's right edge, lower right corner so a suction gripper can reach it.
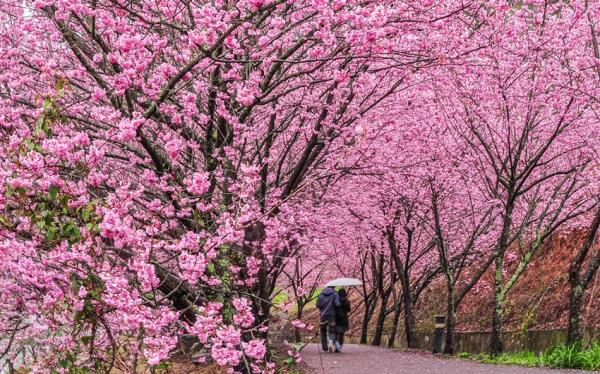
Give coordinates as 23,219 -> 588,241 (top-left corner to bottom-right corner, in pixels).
474,342 -> 600,370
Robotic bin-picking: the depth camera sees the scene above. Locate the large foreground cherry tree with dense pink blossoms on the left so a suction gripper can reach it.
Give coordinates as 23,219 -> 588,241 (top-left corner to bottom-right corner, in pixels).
0,0 -> 490,371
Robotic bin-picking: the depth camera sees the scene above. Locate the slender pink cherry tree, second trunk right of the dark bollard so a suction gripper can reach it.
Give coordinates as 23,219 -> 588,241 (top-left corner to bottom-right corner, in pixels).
436,4 -> 591,354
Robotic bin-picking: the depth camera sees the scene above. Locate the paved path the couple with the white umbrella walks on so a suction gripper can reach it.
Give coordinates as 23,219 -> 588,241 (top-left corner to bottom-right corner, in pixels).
302,344 -> 591,374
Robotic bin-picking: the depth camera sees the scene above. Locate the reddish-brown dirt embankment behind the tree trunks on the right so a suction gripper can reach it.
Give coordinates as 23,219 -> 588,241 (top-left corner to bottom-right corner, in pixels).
458,234 -> 600,330
